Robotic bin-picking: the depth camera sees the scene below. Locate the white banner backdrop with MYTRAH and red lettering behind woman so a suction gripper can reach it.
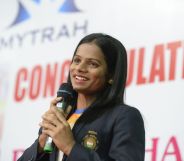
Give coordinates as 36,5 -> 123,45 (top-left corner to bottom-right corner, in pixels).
0,0 -> 184,161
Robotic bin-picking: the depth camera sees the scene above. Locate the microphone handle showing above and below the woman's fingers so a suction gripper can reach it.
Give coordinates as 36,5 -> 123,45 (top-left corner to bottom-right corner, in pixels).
43,101 -> 67,153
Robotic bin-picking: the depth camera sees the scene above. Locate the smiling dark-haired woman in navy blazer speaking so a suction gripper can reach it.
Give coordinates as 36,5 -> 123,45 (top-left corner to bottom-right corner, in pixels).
18,33 -> 145,161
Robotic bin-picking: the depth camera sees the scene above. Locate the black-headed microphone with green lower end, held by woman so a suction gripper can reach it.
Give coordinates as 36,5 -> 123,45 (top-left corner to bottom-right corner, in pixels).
43,83 -> 73,153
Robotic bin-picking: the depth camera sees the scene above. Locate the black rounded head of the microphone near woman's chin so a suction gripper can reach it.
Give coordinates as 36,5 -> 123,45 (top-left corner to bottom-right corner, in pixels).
57,83 -> 73,101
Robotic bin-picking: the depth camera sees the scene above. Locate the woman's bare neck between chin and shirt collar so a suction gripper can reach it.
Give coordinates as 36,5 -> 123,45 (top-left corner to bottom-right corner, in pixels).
77,93 -> 96,109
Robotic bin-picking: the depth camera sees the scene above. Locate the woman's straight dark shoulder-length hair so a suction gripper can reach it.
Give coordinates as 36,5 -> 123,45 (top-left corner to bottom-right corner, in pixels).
68,33 -> 127,119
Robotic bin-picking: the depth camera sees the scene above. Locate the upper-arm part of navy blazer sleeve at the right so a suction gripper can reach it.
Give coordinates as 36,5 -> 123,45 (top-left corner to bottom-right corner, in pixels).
109,108 -> 145,161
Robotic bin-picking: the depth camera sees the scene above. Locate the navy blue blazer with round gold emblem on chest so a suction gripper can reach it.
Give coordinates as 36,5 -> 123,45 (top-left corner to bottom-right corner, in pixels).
18,104 -> 145,161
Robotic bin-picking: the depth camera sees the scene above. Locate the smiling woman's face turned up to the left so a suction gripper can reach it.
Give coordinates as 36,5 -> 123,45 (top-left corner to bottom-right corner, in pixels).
70,43 -> 107,95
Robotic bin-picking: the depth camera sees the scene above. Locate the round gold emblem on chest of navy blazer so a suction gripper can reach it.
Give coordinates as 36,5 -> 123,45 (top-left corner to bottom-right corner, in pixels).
82,131 -> 98,150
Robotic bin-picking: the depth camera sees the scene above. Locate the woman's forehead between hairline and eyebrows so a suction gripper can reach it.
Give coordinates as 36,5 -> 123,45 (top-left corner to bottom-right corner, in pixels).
76,43 -> 105,61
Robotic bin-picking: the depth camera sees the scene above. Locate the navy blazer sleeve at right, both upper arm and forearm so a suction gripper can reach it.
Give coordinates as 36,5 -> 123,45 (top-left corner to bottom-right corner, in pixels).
66,108 -> 145,161
